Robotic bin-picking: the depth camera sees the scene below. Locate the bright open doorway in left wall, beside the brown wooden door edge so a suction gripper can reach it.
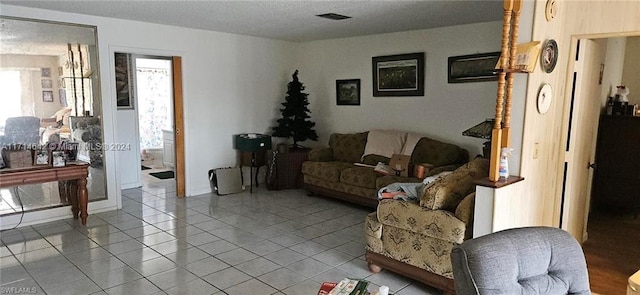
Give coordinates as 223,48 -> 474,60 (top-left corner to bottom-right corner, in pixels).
134,56 -> 175,185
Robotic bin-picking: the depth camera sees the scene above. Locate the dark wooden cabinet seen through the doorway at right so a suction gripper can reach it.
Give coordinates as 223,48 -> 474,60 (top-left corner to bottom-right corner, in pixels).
593,116 -> 640,214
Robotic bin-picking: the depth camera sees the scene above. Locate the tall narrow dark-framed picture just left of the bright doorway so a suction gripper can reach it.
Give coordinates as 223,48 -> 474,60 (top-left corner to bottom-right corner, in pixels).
114,52 -> 134,110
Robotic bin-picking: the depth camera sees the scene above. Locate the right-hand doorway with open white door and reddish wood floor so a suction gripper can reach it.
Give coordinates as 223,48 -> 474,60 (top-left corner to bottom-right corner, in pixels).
560,36 -> 640,294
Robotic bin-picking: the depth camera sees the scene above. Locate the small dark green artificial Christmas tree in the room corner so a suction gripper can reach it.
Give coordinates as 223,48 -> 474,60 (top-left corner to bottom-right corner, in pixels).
273,70 -> 318,149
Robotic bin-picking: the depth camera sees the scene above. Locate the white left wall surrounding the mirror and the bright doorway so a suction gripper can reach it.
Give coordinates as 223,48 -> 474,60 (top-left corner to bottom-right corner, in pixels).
2,5 -> 296,229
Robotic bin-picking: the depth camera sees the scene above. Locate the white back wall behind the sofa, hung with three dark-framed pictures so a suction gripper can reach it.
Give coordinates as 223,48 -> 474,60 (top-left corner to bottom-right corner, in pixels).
300,22 -> 508,161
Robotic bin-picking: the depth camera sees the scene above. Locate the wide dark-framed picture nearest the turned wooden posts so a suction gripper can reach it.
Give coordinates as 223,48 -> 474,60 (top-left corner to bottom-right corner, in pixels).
448,51 -> 500,83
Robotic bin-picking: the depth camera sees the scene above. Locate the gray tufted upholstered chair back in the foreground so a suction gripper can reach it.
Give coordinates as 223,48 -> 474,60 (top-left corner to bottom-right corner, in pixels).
451,227 -> 591,295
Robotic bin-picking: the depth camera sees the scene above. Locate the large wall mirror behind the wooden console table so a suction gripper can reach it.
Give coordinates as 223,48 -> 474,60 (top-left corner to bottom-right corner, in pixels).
0,16 -> 107,215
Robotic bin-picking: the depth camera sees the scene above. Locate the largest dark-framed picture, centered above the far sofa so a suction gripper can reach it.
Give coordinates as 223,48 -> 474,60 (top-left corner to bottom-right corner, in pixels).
371,52 -> 424,96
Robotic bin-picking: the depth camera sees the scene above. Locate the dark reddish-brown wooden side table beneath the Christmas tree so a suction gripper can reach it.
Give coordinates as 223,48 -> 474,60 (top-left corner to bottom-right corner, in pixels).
269,149 -> 309,189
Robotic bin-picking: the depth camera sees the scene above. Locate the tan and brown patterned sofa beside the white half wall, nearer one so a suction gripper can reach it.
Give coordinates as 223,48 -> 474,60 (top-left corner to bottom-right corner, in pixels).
365,158 -> 489,294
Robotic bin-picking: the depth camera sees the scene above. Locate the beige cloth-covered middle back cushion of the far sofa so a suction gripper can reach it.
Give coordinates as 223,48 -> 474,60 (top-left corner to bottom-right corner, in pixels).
363,129 -> 407,158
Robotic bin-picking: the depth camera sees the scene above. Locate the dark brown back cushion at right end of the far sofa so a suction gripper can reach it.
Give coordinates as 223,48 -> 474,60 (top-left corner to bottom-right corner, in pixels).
411,137 -> 466,167
